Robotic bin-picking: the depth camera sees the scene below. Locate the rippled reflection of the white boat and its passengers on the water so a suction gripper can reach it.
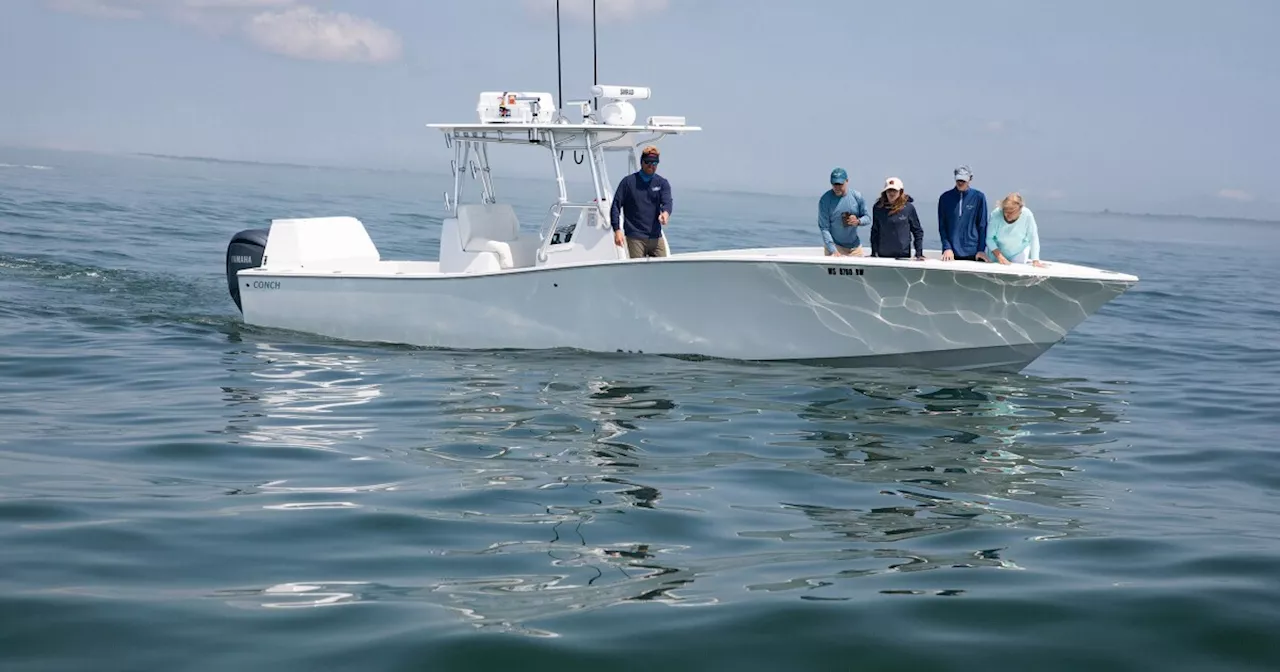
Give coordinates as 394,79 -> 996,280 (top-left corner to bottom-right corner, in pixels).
209,337 -> 1124,636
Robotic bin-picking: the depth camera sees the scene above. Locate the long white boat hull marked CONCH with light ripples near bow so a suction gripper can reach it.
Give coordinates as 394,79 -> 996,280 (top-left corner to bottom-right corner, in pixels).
239,255 -> 1137,371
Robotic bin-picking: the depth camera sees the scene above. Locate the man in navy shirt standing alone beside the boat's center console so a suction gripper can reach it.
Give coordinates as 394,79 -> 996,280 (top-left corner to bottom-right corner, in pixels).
609,145 -> 671,259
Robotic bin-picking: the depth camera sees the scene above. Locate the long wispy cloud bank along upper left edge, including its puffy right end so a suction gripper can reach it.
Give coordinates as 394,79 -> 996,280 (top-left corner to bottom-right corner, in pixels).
46,0 -> 399,63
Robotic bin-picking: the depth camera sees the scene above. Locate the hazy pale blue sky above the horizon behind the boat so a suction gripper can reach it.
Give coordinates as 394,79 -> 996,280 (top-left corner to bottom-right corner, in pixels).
0,0 -> 1280,220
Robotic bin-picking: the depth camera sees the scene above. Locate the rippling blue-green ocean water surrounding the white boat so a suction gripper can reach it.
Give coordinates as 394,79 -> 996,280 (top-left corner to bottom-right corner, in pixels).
0,150 -> 1280,672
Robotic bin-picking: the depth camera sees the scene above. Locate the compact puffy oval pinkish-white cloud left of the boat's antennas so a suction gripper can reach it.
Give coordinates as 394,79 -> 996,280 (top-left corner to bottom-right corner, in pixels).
244,5 -> 401,63
